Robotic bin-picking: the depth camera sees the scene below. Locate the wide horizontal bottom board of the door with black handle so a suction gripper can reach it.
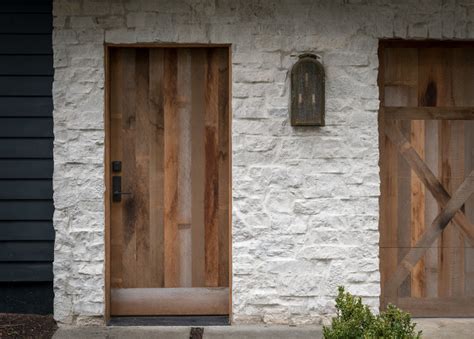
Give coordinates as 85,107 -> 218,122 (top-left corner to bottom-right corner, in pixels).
111,287 -> 229,316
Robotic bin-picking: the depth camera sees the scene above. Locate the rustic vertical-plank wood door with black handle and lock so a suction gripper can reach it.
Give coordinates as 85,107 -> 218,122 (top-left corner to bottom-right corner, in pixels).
108,47 -> 230,316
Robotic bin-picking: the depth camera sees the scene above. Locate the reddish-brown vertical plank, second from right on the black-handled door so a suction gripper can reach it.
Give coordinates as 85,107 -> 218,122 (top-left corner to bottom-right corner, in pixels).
204,50 -> 219,287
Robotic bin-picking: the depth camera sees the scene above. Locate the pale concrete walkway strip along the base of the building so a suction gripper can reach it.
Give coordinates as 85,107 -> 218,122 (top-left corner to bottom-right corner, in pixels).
53,318 -> 474,339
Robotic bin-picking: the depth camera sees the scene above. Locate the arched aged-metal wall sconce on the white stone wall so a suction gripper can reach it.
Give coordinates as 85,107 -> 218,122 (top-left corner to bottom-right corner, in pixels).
290,54 -> 325,126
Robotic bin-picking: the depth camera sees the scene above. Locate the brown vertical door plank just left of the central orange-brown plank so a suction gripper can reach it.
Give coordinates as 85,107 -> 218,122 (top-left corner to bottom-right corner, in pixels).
148,48 -> 164,287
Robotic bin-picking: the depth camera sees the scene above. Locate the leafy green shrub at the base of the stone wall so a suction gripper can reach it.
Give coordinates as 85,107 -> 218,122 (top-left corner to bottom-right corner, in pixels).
323,287 -> 421,339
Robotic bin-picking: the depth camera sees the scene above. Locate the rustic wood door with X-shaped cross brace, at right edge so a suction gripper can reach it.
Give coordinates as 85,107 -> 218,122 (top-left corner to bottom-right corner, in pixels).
379,42 -> 474,317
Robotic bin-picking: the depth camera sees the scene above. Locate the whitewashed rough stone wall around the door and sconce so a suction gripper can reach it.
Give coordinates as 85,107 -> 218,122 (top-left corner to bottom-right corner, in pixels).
53,0 -> 474,324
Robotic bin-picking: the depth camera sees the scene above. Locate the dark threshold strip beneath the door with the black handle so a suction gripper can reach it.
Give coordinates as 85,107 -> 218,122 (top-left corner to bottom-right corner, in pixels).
107,315 -> 230,326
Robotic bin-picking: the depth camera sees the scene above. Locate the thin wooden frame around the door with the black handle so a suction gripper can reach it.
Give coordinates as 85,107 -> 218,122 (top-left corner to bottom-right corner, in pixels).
104,43 -> 232,323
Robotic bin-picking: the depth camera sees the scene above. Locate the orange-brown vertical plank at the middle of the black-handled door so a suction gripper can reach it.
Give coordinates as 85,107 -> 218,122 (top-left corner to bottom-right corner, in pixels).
164,49 -> 180,287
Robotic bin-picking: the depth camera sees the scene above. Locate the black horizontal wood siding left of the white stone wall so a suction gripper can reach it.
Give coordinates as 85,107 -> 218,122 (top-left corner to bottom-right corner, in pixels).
0,0 -> 54,314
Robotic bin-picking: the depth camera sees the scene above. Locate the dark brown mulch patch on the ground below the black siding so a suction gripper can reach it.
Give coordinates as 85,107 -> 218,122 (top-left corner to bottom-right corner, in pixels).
0,313 -> 57,339
